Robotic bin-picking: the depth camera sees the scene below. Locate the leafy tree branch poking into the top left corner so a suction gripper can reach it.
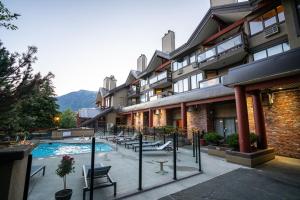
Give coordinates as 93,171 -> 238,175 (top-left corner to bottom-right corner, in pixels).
0,1 -> 20,30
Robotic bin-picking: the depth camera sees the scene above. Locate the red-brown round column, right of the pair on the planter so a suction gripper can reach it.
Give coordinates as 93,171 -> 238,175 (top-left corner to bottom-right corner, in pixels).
252,91 -> 268,149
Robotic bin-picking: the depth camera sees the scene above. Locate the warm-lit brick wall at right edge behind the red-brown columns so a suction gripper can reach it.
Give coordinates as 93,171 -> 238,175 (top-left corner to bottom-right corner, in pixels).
247,90 -> 300,158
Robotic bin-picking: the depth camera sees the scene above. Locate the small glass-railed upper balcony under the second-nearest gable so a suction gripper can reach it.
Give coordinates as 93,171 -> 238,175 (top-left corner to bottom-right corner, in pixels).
149,71 -> 172,88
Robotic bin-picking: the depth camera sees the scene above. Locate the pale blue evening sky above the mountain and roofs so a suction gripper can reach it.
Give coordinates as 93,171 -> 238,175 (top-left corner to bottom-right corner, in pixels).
0,0 -> 209,96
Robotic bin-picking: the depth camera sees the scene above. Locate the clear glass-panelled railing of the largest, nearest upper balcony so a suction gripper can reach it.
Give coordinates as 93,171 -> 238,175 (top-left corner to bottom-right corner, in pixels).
198,33 -> 244,63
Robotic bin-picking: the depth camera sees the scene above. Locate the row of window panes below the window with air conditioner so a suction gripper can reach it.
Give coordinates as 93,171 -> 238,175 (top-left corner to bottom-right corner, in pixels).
253,42 -> 290,61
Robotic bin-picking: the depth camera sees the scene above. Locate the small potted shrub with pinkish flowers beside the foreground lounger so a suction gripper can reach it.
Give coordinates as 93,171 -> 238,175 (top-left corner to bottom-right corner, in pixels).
55,155 -> 75,200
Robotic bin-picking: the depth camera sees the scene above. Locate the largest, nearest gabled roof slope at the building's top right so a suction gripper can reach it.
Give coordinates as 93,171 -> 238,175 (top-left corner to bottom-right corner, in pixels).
170,1 -> 253,59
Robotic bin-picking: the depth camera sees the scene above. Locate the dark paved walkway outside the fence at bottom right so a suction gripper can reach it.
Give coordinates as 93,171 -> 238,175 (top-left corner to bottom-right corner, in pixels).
161,156 -> 300,200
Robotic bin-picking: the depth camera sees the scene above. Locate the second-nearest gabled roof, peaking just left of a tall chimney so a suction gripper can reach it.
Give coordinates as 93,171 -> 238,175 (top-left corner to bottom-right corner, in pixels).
139,50 -> 170,78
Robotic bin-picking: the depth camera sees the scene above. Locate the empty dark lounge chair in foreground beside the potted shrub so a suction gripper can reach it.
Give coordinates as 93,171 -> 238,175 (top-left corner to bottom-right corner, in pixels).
82,164 -> 117,200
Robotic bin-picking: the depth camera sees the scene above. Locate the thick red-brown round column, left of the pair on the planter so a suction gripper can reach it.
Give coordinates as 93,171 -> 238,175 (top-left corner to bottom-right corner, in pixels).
234,86 -> 251,153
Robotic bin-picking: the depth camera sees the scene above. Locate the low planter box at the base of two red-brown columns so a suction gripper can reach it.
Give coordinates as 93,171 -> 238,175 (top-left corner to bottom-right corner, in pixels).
225,148 -> 275,167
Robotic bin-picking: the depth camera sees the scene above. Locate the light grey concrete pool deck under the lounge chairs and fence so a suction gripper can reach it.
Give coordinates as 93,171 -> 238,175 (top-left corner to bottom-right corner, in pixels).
29,138 -> 241,200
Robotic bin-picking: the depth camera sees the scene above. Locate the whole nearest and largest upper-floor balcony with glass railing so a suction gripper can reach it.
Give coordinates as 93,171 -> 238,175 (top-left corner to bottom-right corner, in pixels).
198,33 -> 248,70
